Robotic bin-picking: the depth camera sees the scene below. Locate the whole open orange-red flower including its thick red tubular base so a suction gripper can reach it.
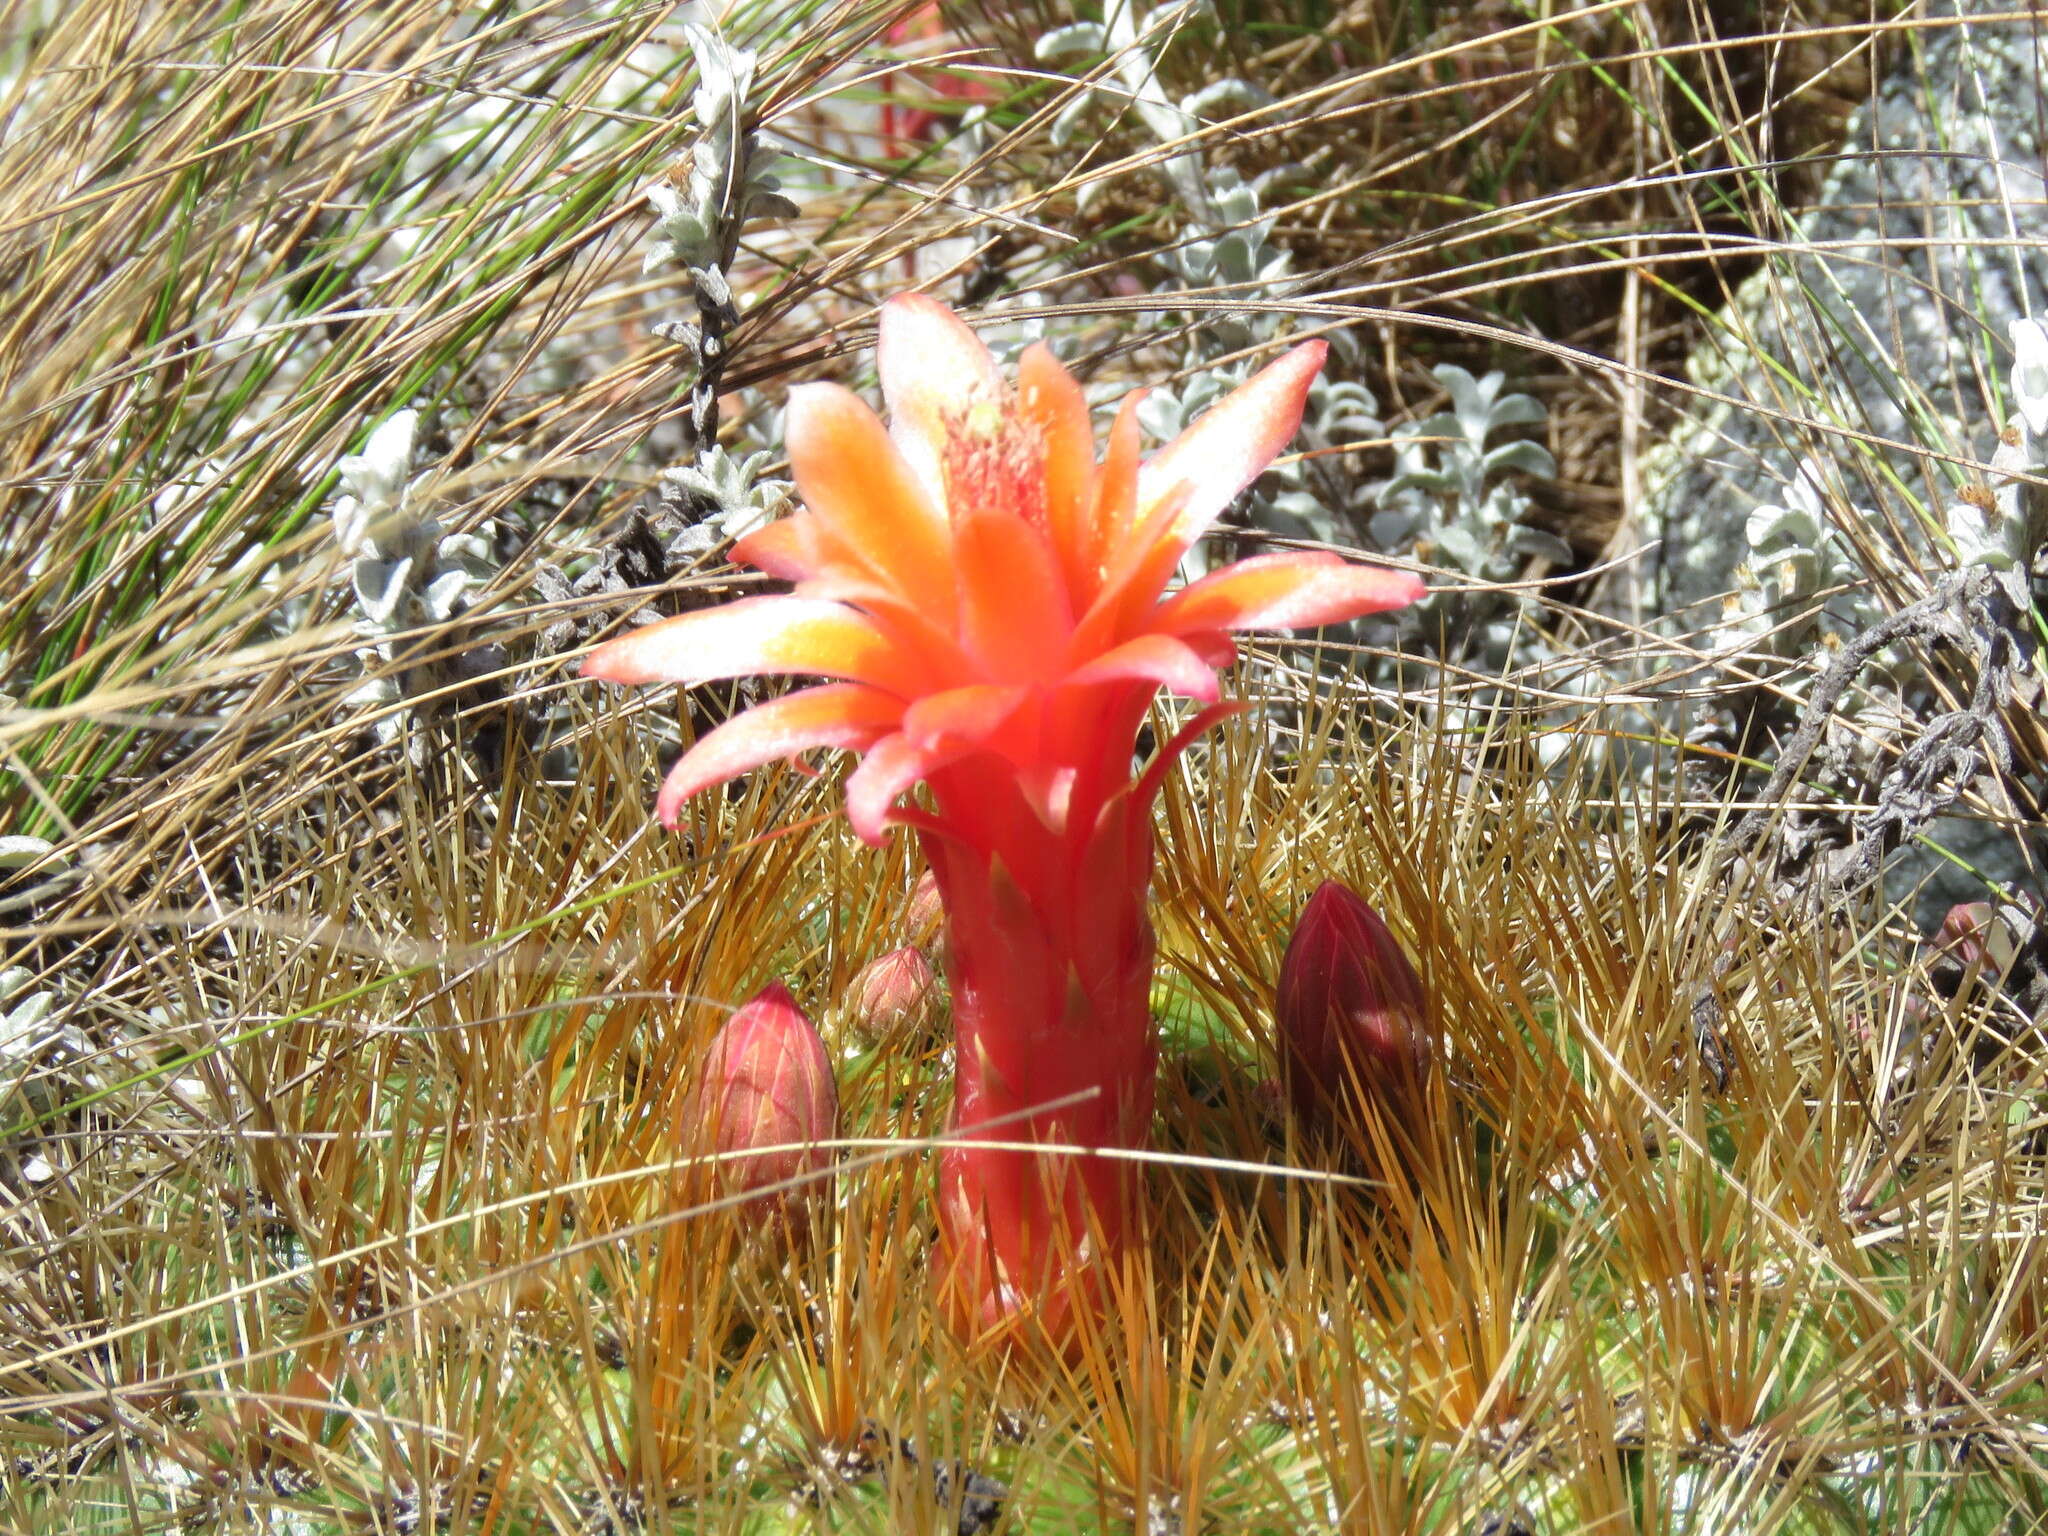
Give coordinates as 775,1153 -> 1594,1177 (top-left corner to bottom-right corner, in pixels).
584,295 -> 1421,1325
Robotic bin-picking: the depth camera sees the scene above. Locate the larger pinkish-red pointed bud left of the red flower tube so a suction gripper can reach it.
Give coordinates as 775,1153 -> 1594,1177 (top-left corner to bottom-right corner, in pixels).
696,981 -> 840,1204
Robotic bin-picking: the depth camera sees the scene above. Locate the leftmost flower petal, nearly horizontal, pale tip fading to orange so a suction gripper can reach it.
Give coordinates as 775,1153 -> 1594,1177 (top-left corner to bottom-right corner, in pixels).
582,596 -> 928,698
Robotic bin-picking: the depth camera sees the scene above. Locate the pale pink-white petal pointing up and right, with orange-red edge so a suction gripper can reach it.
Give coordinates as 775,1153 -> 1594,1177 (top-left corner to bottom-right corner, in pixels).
1139,342 -> 1329,553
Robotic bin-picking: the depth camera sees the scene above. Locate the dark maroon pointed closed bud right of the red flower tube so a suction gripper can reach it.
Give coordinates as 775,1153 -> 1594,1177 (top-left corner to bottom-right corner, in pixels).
1274,881 -> 1430,1118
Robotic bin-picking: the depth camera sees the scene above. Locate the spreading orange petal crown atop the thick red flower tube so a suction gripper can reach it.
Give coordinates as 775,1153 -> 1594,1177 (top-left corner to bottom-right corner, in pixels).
584,295 -> 1421,842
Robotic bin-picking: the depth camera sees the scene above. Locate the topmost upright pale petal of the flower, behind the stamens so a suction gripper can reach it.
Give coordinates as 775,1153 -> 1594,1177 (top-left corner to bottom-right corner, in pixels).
874,293 -> 1008,518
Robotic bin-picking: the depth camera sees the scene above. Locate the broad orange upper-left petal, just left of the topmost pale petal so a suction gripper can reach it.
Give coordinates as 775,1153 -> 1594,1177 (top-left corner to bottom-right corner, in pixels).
786,382 -> 954,616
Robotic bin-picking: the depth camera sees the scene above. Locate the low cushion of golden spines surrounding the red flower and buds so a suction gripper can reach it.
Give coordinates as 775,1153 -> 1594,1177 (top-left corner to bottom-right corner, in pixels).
8,679 -> 2044,1530
